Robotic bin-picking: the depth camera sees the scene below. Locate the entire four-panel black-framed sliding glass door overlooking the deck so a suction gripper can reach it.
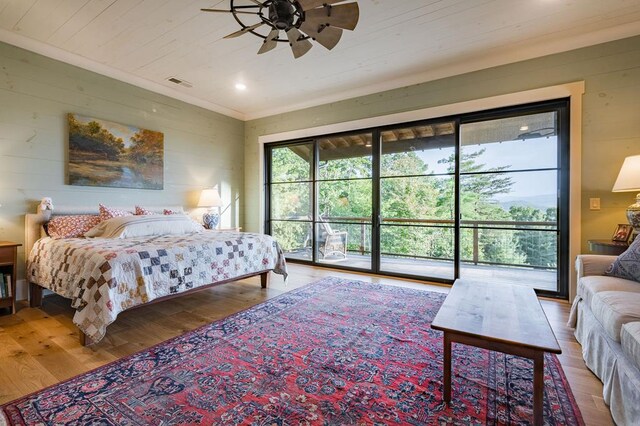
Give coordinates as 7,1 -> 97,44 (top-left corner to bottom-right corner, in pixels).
265,101 -> 569,297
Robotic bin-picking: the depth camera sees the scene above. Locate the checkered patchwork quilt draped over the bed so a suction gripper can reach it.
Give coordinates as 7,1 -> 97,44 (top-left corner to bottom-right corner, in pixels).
27,231 -> 287,342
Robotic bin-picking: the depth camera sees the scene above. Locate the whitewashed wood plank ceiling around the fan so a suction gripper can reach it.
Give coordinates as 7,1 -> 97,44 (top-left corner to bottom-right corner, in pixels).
0,0 -> 640,119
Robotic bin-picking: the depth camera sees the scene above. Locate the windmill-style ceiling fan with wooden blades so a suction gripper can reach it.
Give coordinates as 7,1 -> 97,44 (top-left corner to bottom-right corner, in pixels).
200,0 -> 360,59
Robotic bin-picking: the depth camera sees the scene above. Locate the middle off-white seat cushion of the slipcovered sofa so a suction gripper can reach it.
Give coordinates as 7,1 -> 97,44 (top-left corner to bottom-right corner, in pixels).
591,291 -> 640,342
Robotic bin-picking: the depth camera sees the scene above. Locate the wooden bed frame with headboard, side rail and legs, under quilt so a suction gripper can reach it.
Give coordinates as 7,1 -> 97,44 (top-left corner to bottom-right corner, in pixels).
25,206 -> 271,346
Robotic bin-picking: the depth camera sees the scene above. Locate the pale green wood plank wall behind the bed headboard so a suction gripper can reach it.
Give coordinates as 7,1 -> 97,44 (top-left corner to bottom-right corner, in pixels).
0,43 -> 244,296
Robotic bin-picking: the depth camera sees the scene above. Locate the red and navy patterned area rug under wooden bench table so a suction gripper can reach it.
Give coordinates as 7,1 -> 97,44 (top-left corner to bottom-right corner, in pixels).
0,278 -> 583,425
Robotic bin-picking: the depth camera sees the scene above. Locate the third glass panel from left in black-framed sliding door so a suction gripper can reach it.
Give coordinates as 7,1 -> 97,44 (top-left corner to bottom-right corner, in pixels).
379,121 -> 457,280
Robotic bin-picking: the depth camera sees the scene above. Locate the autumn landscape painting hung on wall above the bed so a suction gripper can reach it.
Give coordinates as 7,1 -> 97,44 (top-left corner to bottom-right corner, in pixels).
67,114 -> 164,189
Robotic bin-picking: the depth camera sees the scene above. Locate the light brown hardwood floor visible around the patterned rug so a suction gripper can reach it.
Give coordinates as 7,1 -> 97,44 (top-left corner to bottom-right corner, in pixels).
0,264 -> 613,426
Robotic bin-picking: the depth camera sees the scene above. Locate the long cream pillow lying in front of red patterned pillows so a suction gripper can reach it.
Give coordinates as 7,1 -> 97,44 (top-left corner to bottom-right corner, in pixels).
84,214 -> 204,238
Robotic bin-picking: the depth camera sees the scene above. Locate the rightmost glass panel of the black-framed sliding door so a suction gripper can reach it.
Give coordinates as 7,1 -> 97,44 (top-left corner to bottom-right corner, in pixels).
460,106 -> 568,293
